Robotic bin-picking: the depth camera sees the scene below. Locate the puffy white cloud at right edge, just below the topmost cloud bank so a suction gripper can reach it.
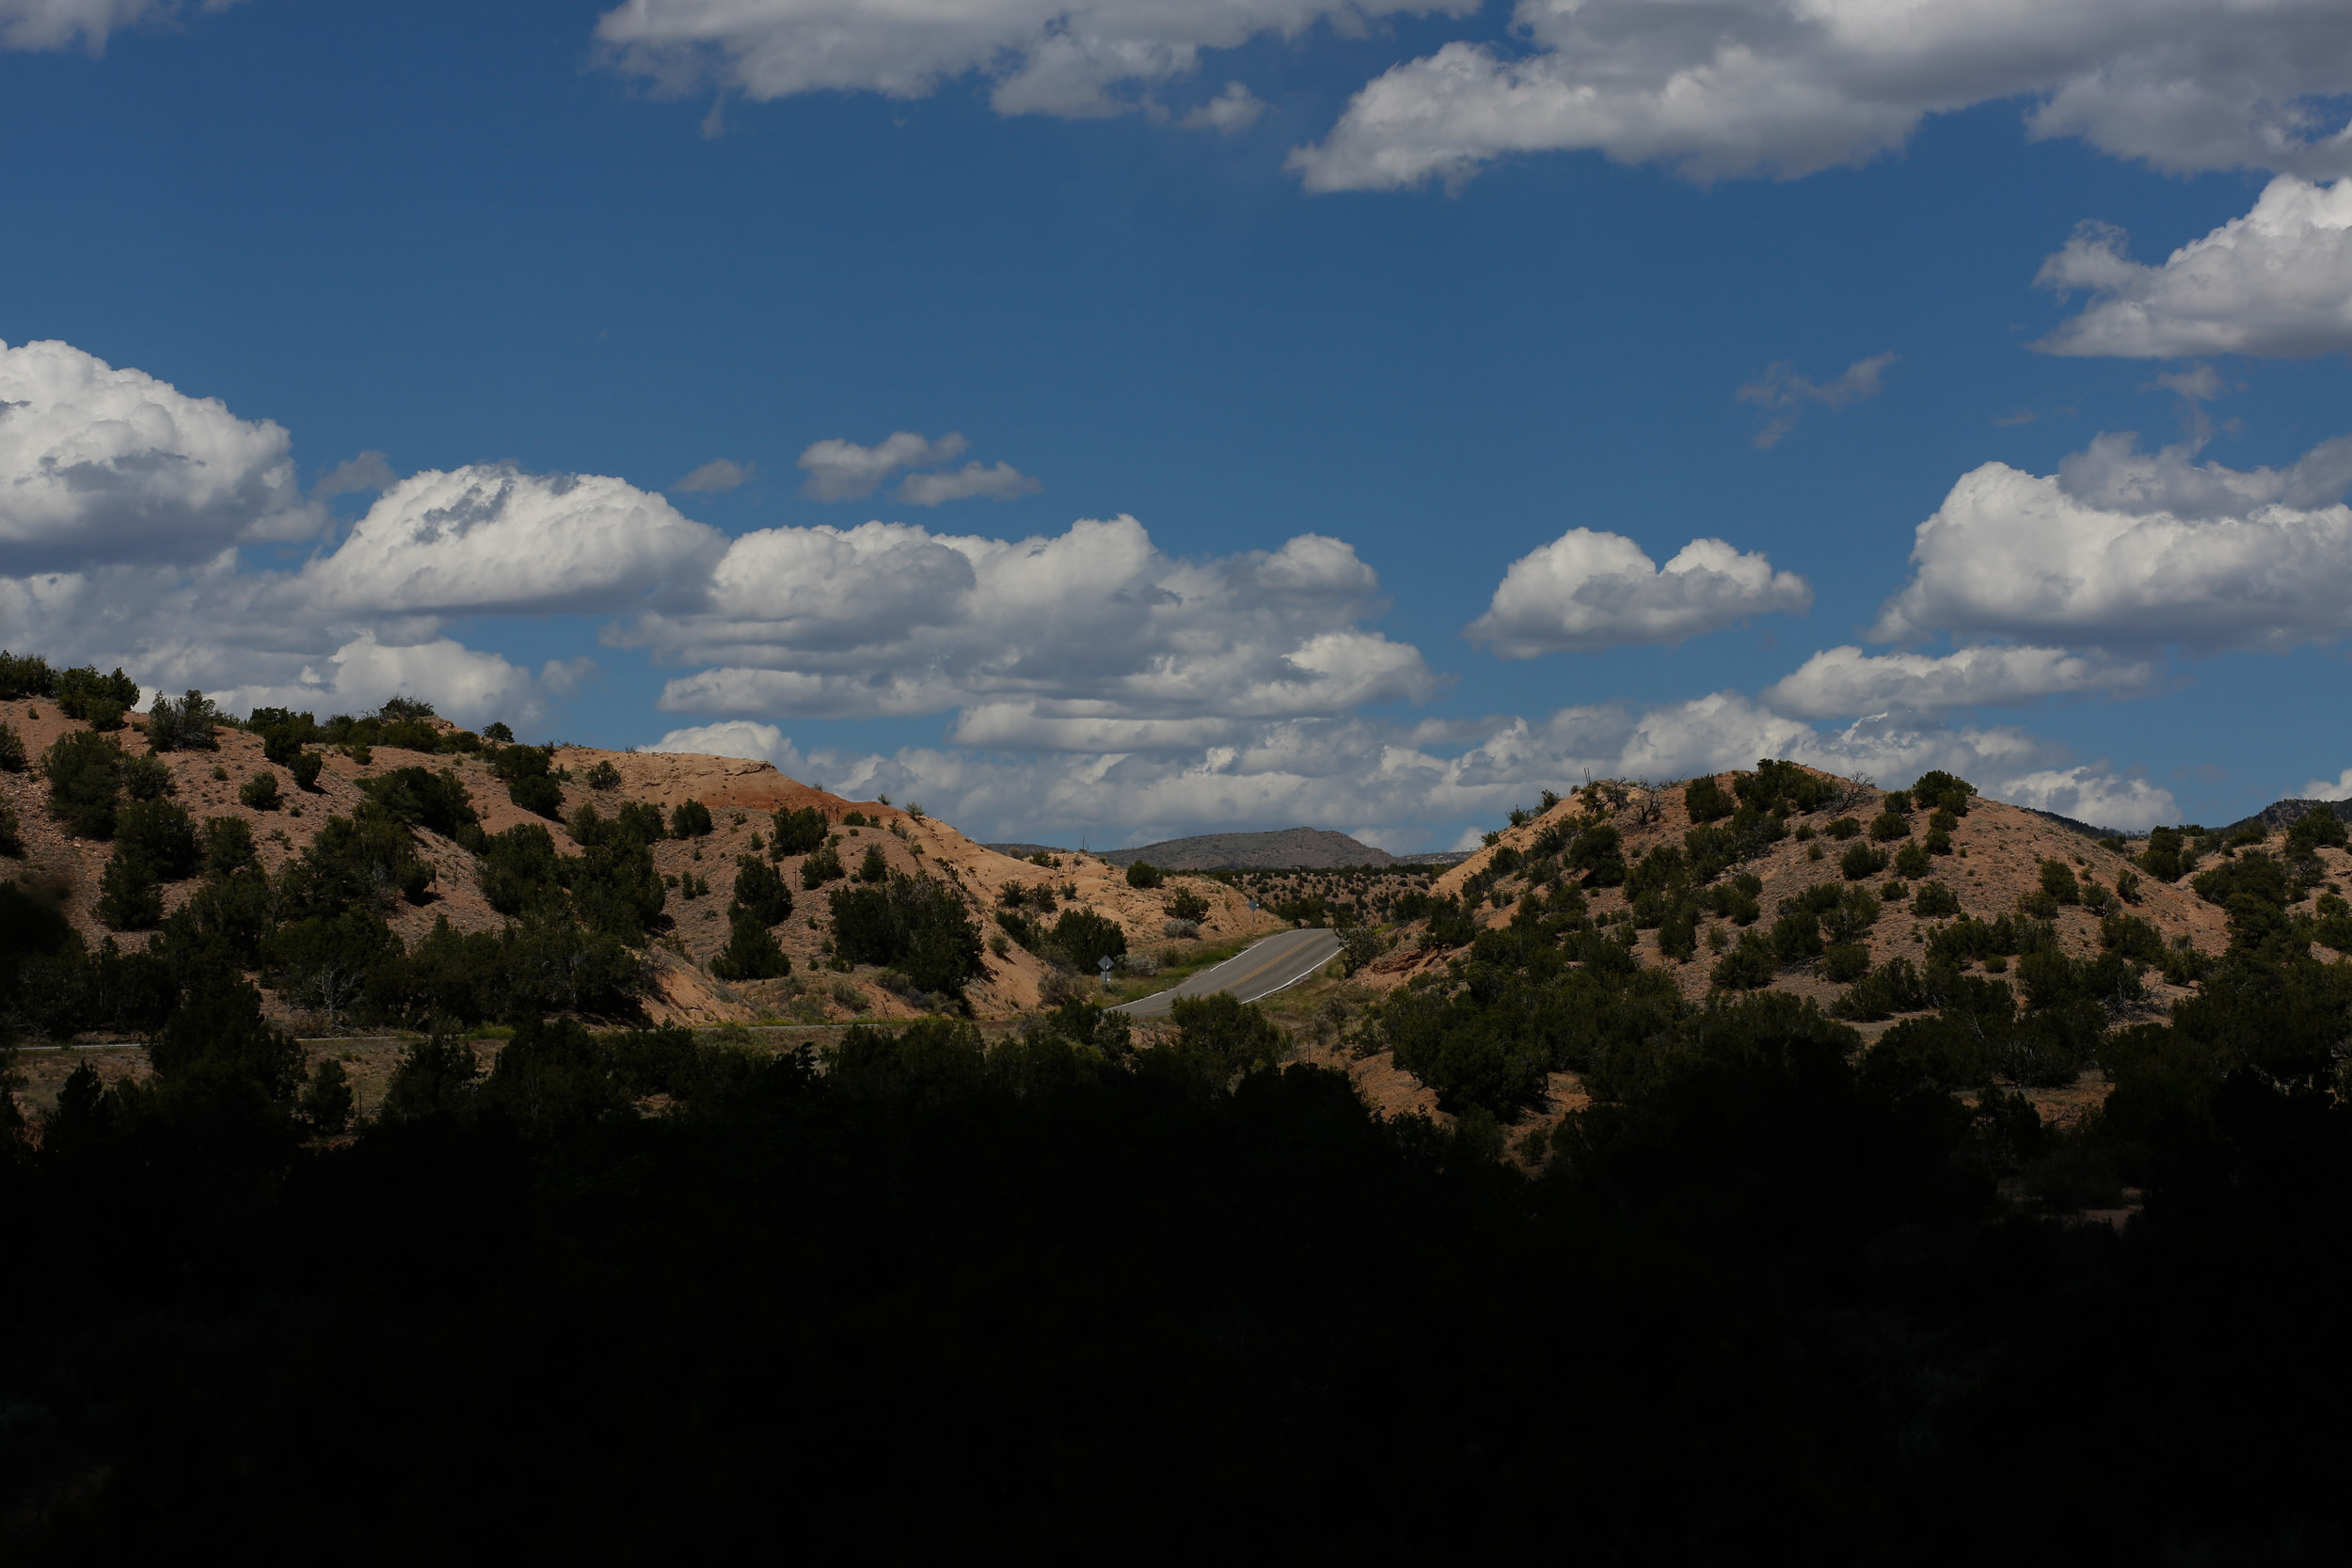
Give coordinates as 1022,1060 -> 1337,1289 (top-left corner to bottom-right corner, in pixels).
2035,174 -> 2352,359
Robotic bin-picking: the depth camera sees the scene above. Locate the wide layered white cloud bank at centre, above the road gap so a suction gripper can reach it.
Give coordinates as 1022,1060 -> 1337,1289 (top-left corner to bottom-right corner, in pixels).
612,517 -> 1435,748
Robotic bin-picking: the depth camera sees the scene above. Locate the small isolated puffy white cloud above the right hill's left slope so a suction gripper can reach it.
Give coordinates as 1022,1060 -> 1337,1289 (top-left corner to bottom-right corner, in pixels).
1466,529 -> 1814,658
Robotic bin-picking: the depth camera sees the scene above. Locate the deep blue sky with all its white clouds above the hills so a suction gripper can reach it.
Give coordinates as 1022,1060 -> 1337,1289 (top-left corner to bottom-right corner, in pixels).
0,0 -> 2352,848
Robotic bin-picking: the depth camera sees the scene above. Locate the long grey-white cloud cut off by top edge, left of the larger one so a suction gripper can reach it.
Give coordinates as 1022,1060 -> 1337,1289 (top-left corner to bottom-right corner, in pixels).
596,0 -> 1477,129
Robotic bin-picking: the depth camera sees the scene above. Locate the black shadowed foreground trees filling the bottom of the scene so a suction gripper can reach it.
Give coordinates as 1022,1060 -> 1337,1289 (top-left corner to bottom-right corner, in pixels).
0,919 -> 2352,1563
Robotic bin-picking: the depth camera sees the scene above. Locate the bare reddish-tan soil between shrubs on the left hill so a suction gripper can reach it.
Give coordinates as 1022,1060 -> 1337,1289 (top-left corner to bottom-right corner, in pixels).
0,698 -> 1263,1025
